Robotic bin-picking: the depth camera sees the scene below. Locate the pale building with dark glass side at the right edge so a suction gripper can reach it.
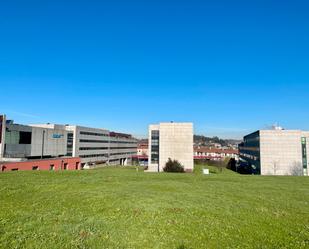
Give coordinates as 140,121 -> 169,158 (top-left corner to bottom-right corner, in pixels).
239,129 -> 309,175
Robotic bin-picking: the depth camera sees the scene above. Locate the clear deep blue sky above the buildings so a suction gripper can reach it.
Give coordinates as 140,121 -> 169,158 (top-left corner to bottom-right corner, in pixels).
0,0 -> 309,138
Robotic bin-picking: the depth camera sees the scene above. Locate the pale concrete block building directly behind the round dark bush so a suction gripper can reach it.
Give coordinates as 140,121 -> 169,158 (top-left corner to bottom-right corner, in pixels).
148,122 -> 194,172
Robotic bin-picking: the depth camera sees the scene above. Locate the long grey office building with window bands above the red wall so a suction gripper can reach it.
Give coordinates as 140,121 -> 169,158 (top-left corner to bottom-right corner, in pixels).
0,116 -> 137,168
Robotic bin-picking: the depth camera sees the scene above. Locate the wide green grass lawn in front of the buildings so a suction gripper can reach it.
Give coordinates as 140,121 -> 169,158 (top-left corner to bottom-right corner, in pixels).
0,166 -> 309,249
